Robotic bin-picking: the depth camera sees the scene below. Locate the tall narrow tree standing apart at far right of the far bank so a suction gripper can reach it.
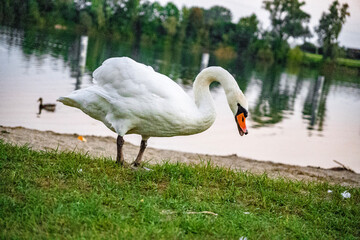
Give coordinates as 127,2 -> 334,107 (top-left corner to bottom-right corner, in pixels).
315,0 -> 350,59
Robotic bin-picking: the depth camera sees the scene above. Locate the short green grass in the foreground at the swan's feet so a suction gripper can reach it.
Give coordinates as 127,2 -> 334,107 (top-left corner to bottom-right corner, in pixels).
0,141 -> 360,239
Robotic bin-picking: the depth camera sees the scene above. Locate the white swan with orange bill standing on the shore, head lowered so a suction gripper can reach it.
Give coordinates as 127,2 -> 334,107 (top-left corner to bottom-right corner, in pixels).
58,57 -> 248,166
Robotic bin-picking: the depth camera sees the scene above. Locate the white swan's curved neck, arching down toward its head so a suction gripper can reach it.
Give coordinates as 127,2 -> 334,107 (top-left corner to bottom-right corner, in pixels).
193,67 -> 245,115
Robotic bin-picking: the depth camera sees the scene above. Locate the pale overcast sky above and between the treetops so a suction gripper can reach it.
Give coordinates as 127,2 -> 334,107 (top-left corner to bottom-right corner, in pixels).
152,0 -> 360,49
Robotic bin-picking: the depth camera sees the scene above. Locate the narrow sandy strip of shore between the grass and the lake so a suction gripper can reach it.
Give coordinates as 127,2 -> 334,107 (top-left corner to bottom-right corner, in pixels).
0,126 -> 360,187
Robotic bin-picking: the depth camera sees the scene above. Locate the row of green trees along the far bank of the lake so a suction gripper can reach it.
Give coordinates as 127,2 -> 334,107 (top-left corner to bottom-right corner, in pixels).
0,0 -> 349,62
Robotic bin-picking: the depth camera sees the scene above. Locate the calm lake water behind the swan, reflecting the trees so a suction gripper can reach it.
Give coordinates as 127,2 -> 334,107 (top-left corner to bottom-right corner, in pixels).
0,27 -> 360,172
